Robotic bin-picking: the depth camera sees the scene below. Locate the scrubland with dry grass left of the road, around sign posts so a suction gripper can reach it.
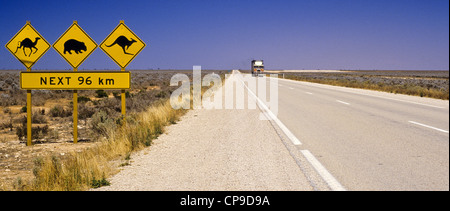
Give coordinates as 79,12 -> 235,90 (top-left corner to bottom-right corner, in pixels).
0,70 -> 225,190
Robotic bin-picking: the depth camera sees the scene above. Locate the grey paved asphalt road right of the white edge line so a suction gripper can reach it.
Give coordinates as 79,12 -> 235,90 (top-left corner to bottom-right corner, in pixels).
253,73 -> 449,191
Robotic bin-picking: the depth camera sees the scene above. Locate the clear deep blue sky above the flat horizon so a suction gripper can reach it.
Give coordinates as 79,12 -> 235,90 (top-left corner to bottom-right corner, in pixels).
0,0 -> 449,70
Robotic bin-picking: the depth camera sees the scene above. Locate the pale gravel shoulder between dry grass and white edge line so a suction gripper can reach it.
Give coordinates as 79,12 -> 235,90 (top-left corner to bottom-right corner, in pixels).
97,106 -> 312,191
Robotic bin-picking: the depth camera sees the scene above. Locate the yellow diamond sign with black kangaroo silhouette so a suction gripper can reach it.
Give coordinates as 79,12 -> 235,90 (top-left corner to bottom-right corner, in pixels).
100,21 -> 145,68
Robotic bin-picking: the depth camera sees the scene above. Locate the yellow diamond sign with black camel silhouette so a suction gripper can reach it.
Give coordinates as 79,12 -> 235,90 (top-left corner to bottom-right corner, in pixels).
5,21 -> 51,69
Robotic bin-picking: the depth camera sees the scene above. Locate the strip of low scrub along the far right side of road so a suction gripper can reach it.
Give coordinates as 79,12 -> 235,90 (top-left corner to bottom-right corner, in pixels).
285,71 -> 449,100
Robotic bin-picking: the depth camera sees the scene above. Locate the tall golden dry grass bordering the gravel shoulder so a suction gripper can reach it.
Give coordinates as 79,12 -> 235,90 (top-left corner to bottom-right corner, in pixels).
14,100 -> 186,191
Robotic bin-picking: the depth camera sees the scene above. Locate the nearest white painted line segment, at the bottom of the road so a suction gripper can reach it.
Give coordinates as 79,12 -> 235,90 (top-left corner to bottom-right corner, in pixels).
300,150 -> 345,191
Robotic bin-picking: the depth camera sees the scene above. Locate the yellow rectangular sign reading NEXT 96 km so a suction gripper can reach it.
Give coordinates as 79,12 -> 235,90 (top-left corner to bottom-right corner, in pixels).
20,71 -> 131,90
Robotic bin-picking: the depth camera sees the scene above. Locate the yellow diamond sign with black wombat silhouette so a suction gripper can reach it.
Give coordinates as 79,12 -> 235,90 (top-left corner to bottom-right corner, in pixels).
53,21 -> 97,69
